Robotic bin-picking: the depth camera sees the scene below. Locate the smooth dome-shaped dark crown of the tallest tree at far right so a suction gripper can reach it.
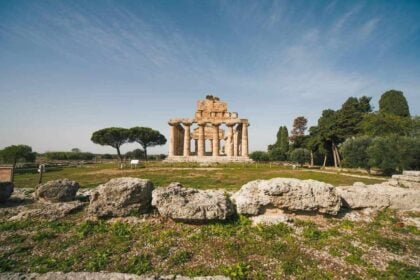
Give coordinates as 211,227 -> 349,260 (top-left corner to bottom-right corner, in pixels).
379,90 -> 410,117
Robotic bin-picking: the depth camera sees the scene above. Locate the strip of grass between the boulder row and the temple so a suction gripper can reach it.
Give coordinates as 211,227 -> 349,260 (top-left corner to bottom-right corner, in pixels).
15,162 -> 379,190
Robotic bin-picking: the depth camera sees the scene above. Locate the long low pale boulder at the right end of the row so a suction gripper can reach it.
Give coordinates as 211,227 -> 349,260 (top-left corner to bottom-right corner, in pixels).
336,182 -> 420,210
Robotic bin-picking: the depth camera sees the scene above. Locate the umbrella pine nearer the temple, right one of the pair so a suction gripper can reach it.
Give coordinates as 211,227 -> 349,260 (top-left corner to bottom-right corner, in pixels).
130,126 -> 166,160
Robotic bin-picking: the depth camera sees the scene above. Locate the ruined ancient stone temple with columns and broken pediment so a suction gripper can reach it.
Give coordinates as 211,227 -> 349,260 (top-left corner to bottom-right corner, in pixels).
166,95 -> 251,162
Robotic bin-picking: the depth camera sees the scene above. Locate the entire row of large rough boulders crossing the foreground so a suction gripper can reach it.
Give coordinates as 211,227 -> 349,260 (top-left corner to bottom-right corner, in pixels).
0,171 -> 420,223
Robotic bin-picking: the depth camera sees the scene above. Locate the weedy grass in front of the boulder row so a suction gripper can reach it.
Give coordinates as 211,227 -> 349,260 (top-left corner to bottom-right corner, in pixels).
0,211 -> 420,279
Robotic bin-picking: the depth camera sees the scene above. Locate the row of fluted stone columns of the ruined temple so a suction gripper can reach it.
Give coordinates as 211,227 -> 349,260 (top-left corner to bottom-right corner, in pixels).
169,123 -> 248,157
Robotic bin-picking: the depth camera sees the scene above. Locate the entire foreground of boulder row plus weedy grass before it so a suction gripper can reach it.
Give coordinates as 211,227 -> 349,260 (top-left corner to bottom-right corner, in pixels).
0,172 -> 420,279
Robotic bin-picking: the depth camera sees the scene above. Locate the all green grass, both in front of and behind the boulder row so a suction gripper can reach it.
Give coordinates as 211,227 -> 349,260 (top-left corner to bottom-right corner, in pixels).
0,162 -> 420,279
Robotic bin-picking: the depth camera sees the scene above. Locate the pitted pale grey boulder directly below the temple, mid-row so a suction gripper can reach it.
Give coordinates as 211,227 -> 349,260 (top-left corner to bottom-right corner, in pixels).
152,183 -> 235,223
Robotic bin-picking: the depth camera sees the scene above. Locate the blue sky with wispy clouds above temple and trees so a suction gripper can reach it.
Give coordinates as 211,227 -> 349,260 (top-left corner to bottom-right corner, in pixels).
0,0 -> 420,153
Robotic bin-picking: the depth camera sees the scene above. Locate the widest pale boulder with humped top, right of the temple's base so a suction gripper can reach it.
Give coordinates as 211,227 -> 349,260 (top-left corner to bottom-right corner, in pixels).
232,178 -> 341,216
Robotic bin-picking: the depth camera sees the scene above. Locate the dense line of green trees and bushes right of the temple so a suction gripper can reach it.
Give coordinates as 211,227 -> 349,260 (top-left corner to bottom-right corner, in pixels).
251,90 -> 420,174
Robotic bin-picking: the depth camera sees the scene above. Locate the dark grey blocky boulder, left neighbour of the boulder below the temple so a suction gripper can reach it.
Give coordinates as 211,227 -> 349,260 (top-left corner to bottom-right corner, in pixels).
88,177 -> 153,217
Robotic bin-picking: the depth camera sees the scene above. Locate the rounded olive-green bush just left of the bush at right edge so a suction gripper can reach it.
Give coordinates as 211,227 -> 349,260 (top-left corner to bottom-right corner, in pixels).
341,136 -> 372,169
